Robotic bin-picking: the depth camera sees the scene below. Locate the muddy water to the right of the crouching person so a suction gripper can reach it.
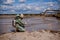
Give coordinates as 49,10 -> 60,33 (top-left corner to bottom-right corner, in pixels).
25,17 -> 60,31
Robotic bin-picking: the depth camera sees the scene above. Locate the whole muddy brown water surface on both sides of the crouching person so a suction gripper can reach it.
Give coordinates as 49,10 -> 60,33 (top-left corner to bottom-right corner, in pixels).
0,17 -> 60,33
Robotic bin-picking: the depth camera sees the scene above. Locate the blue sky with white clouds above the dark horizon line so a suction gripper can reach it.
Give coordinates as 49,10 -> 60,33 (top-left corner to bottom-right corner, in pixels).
0,0 -> 60,14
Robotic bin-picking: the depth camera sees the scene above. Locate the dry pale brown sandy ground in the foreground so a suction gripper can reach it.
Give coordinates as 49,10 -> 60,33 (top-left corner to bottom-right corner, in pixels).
0,30 -> 60,40
